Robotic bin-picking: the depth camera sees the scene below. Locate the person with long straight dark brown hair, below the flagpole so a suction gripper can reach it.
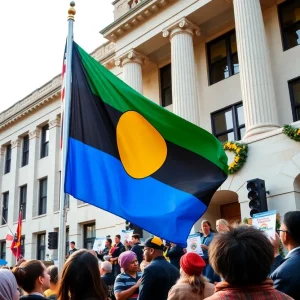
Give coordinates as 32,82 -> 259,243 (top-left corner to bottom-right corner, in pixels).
57,249 -> 108,300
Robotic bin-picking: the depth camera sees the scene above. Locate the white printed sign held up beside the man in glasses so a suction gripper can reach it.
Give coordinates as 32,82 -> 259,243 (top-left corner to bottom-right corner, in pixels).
252,210 -> 276,239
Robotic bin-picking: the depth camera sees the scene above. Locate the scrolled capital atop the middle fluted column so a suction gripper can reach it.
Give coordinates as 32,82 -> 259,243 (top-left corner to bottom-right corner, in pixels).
162,18 -> 201,39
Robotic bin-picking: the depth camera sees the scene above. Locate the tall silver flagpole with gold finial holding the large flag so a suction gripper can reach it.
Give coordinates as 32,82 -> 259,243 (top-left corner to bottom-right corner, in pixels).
58,1 -> 76,270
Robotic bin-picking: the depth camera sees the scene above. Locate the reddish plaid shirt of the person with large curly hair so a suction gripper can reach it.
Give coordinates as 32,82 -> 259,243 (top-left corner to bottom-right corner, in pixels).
205,278 -> 293,300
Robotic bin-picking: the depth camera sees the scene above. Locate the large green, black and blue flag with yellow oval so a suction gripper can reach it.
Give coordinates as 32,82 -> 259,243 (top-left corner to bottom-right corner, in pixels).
65,43 -> 228,245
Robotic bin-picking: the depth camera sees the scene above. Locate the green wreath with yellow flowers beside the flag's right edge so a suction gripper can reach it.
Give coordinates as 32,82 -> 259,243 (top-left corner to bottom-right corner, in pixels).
223,142 -> 248,174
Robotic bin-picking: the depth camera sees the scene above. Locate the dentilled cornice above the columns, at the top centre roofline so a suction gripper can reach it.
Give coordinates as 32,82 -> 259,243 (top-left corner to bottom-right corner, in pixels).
100,0 -> 177,42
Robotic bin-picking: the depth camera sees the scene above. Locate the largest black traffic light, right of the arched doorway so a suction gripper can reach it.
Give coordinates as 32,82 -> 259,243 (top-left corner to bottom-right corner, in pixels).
247,178 -> 268,217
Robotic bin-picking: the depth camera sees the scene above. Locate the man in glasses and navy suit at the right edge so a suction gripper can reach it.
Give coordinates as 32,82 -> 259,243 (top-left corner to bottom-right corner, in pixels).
271,211 -> 300,299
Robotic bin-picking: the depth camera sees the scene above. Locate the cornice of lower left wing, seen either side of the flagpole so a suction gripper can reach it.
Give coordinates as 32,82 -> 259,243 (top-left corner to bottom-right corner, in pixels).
0,42 -> 115,132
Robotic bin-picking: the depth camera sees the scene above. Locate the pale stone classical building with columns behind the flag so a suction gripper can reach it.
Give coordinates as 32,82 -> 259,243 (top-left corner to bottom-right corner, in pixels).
0,0 -> 300,263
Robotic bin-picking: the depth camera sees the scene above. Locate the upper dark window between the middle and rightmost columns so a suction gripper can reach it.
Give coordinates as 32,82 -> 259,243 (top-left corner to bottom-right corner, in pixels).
207,31 -> 240,84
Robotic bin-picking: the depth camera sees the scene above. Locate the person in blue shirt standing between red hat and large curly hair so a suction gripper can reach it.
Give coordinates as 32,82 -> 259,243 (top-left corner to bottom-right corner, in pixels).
201,220 -> 221,283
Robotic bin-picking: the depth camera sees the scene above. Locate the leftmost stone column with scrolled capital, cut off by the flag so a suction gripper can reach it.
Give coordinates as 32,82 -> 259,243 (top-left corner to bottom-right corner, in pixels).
116,50 -> 146,94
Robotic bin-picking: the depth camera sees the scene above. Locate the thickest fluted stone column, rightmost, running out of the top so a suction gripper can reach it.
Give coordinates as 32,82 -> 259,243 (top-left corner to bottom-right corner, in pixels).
233,0 -> 279,138
